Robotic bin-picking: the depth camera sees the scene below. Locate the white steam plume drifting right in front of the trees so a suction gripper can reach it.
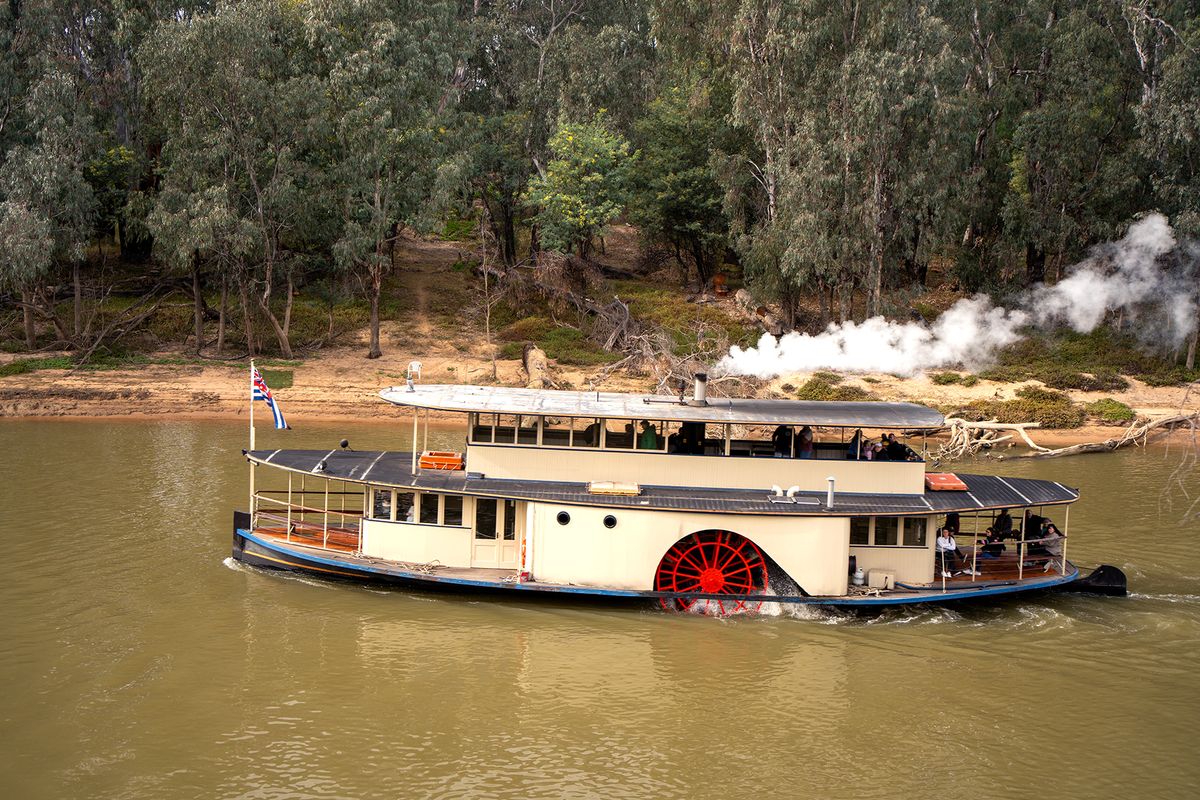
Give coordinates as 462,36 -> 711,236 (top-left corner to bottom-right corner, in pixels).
714,213 -> 1198,378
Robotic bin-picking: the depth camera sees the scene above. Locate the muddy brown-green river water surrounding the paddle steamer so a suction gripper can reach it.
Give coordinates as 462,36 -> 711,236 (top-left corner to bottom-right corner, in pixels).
0,422 -> 1200,798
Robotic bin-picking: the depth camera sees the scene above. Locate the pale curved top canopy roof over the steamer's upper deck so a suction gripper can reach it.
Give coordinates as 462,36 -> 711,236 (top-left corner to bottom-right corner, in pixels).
379,384 -> 943,428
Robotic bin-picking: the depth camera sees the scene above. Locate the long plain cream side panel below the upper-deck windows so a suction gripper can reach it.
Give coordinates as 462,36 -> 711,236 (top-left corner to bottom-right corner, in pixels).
467,445 -> 925,494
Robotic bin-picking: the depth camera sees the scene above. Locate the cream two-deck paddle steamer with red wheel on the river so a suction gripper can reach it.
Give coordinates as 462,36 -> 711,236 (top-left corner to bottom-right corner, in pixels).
233,375 -> 1123,614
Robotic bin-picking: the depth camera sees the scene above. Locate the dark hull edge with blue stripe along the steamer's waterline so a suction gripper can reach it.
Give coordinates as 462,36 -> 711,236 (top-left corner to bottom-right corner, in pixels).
233,529 -> 1079,608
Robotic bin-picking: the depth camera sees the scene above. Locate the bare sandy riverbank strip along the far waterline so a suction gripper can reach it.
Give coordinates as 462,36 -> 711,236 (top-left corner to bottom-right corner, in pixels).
0,340 -> 1200,446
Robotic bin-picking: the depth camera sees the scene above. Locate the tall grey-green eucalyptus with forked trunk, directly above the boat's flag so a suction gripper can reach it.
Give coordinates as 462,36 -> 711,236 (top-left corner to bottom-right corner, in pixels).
140,0 -> 319,357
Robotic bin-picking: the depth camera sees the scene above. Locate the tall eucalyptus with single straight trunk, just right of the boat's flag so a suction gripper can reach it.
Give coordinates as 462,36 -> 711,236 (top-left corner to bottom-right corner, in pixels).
308,0 -> 455,359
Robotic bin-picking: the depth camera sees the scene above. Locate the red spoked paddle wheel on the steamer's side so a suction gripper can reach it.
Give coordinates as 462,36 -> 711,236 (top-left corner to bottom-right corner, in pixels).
654,530 -> 767,614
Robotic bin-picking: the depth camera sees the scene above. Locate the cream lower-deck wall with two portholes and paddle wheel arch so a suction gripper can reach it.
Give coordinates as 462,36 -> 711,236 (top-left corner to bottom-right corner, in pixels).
530,504 -> 850,595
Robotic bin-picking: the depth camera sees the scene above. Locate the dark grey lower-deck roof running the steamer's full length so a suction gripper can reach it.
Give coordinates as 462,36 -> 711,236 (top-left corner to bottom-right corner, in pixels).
250,450 -> 1079,516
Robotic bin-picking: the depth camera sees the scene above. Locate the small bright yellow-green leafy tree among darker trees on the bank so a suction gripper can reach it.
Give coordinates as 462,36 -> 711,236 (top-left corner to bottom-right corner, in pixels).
527,114 -> 634,255
